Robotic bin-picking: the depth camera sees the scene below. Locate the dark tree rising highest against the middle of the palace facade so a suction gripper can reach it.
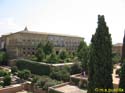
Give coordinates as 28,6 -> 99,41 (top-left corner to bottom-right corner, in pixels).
44,41 -> 53,55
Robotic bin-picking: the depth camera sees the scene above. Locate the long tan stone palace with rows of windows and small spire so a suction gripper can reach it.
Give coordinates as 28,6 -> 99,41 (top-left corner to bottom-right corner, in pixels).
0,27 -> 84,58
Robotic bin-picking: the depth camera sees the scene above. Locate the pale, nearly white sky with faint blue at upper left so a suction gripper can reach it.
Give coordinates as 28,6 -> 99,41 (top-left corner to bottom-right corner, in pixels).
0,0 -> 125,43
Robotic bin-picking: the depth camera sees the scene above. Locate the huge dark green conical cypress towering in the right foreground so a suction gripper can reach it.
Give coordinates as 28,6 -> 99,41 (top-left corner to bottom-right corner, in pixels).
88,15 -> 113,93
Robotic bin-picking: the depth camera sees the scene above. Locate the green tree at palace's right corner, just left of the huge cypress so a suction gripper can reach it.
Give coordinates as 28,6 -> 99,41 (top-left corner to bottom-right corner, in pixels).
77,41 -> 89,71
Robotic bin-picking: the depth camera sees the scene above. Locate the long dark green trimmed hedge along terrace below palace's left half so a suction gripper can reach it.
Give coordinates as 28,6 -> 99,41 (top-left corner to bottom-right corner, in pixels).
16,59 -> 51,75
